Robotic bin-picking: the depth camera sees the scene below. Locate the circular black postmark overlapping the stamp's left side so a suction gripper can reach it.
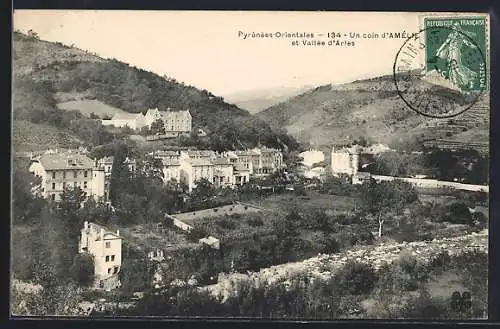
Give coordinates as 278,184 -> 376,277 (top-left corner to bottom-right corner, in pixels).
393,25 -> 486,118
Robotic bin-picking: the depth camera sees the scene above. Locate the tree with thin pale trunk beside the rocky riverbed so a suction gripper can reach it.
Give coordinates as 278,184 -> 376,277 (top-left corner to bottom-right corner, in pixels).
361,179 -> 418,238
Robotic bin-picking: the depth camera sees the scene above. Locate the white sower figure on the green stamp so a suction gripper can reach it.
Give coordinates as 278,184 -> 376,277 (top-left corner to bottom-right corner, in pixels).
436,23 -> 477,88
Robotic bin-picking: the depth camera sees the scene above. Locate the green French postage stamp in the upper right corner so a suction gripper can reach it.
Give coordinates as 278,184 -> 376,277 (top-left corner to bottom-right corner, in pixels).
424,17 -> 488,92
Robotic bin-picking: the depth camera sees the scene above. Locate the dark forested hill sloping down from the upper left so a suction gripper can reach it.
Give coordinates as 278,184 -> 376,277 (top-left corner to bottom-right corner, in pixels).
13,32 -> 296,148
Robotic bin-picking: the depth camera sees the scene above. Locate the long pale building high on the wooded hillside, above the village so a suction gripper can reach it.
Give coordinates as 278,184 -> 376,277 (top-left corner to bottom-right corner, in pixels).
102,108 -> 192,135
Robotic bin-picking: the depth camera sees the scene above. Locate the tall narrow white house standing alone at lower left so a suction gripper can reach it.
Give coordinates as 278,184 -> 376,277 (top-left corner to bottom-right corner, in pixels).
78,221 -> 122,290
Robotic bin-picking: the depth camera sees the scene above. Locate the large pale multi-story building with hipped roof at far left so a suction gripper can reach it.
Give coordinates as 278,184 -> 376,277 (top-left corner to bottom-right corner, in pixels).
29,151 -> 105,202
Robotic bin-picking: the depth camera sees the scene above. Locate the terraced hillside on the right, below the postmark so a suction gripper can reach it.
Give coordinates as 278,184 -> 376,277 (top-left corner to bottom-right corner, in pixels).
258,76 -> 489,146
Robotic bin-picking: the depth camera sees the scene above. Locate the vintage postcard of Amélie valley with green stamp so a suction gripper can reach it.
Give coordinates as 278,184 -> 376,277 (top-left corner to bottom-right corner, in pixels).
10,10 -> 490,320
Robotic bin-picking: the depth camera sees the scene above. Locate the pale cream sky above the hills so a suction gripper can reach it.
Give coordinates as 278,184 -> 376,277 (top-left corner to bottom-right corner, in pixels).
13,10 -> 434,96
